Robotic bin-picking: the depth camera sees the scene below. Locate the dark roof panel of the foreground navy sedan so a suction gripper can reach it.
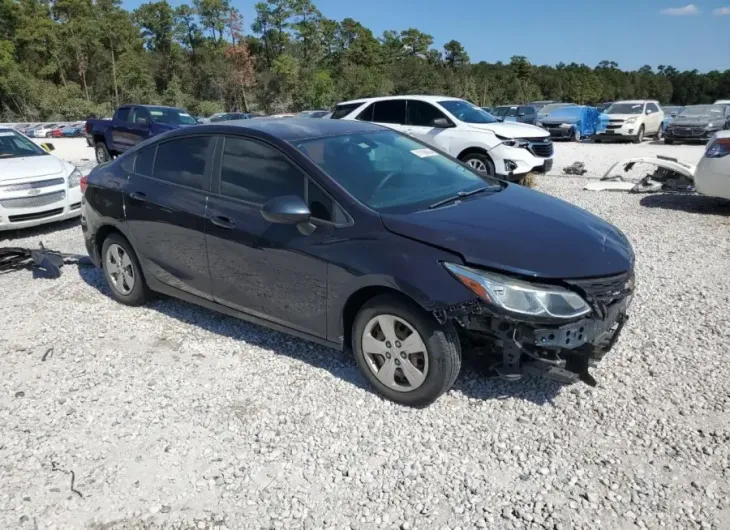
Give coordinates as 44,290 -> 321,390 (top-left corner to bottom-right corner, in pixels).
156,118 -> 391,143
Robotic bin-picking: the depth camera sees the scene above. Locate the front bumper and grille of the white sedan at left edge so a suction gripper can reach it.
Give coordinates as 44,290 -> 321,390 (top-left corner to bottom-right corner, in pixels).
0,175 -> 81,231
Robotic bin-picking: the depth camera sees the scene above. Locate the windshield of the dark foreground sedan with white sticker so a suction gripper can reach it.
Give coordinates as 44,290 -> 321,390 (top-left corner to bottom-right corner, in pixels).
296,131 -> 502,213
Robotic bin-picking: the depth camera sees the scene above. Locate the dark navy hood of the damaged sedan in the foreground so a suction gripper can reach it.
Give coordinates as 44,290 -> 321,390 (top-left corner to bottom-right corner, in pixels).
382,184 -> 634,279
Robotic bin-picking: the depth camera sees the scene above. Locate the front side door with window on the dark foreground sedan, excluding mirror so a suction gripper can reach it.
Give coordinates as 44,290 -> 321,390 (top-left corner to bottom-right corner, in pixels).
206,136 -> 334,337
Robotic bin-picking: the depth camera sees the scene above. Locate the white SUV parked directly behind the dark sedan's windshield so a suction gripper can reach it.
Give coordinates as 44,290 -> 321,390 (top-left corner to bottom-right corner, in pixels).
331,96 -> 553,181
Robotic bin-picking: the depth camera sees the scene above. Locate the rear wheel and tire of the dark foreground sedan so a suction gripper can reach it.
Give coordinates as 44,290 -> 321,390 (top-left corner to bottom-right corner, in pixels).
101,234 -> 150,306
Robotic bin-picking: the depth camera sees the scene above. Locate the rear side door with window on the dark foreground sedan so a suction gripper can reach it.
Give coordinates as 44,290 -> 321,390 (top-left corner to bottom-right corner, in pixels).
124,135 -> 215,299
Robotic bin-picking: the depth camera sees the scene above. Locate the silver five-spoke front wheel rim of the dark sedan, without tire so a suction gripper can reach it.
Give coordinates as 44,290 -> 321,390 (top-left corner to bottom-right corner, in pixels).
361,314 -> 428,392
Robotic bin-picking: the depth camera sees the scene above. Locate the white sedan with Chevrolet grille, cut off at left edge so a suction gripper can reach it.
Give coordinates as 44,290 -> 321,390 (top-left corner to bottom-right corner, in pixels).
0,128 -> 82,231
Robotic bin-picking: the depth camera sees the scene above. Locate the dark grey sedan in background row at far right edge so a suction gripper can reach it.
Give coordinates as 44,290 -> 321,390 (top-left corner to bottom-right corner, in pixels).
664,105 -> 730,144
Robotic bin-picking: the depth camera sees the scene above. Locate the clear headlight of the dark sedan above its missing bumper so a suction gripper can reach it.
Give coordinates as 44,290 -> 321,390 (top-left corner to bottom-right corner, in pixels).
444,263 -> 591,319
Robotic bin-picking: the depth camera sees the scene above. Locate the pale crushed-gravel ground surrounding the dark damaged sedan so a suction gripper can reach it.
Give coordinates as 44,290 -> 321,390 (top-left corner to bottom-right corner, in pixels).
0,138 -> 730,530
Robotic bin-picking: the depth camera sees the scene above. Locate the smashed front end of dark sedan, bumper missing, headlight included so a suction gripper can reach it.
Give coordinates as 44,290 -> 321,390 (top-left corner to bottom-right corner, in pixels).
434,264 -> 634,386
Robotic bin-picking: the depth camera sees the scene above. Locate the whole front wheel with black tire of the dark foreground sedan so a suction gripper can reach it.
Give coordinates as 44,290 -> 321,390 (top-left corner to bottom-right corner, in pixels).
352,295 -> 461,408
